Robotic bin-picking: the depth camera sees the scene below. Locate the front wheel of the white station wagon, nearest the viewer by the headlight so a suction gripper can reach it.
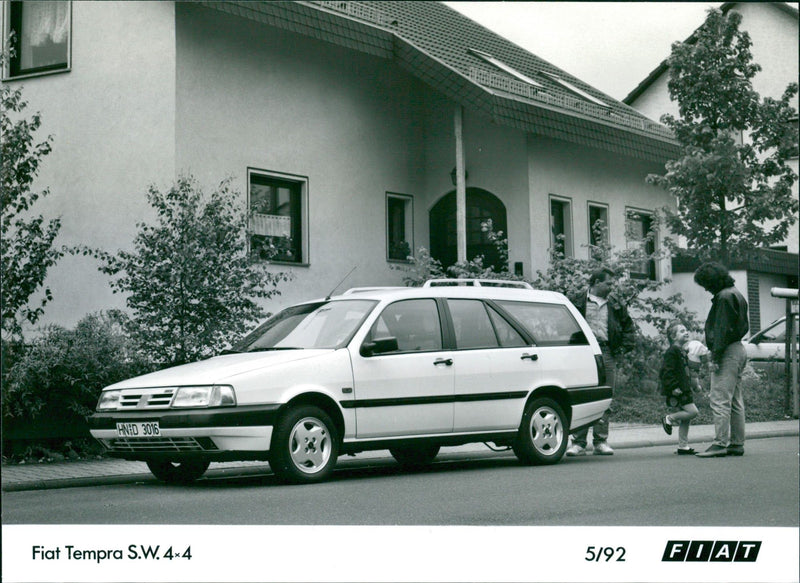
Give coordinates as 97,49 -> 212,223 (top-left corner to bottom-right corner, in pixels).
269,405 -> 339,484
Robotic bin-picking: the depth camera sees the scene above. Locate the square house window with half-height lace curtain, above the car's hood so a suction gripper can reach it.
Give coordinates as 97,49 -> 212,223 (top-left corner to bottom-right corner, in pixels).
248,170 -> 308,263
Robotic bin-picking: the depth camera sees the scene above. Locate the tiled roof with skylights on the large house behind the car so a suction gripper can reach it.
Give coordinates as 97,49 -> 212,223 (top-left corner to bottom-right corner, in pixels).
198,1 -> 678,162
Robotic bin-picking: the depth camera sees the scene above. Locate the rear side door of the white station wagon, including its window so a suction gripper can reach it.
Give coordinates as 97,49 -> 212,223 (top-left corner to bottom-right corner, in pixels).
447,299 -> 538,432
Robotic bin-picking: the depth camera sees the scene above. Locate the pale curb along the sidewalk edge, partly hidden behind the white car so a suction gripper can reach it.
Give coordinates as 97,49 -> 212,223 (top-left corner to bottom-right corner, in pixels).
2,427 -> 800,492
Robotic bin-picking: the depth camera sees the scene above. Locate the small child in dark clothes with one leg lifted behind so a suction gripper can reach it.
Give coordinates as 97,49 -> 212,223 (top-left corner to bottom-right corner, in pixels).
660,322 -> 698,455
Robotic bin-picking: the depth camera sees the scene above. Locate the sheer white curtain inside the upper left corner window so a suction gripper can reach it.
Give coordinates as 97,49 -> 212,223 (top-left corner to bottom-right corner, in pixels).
20,1 -> 69,69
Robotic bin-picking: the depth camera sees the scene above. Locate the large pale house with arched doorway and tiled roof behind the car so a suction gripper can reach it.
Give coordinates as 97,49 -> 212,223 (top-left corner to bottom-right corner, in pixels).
2,1 -> 678,334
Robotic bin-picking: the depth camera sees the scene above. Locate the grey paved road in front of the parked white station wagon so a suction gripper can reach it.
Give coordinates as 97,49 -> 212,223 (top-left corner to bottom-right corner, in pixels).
2,437 -> 800,527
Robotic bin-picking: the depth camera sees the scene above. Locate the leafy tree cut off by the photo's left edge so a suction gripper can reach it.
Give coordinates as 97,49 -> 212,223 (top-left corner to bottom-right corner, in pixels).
0,45 -> 63,341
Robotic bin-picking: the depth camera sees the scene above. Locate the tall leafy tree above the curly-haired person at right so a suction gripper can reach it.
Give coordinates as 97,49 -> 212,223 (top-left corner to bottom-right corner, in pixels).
648,9 -> 798,263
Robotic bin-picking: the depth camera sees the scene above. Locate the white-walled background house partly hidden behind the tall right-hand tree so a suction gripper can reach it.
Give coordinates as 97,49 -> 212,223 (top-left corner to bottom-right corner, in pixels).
623,2 -> 800,332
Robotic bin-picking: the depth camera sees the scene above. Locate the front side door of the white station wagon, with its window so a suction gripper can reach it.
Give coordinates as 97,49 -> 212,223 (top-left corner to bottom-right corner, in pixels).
352,298 -> 454,439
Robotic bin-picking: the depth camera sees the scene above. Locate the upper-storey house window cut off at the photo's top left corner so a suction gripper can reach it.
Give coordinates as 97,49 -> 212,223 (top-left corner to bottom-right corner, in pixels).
8,1 -> 71,77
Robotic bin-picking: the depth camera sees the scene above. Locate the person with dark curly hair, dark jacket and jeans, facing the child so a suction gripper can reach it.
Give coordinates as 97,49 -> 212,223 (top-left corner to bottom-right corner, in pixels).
694,262 -> 750,458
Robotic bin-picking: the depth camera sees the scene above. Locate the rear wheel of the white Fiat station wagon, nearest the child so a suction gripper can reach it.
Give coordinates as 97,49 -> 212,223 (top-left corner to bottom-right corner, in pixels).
512,398 -> 569,465
